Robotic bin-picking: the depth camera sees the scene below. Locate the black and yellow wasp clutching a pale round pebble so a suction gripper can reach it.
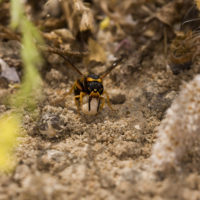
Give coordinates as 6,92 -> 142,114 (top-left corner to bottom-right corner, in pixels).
57,56 -> 124,115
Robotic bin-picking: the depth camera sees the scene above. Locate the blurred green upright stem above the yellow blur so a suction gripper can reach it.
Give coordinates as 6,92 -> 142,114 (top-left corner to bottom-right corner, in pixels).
11,0 -> 43,109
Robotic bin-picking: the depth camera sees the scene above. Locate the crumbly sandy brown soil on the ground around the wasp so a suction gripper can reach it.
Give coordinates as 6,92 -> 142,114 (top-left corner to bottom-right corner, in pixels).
0,1 -> 200,200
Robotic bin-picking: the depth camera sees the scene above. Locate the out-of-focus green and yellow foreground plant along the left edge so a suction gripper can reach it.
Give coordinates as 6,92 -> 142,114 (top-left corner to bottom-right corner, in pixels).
0,0 -> 42,171
